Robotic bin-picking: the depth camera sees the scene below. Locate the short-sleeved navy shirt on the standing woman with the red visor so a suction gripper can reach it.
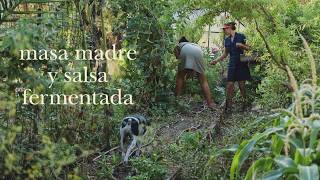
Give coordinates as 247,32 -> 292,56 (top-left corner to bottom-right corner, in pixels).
224,32 -> 246,68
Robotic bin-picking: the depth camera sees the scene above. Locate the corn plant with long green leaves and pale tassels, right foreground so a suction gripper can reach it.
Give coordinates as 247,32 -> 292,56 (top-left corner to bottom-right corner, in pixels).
230,35 -> 320,180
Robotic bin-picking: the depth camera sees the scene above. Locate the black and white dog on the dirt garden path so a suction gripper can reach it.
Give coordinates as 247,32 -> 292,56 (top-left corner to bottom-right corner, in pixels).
120,114 -> 150,163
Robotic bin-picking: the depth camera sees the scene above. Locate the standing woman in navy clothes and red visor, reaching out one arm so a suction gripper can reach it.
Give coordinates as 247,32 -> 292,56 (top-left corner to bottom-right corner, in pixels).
211,22 -> 251,111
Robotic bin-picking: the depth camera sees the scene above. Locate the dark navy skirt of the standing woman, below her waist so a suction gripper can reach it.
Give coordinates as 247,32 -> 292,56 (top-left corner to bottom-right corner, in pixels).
227,63 -> 251,82
